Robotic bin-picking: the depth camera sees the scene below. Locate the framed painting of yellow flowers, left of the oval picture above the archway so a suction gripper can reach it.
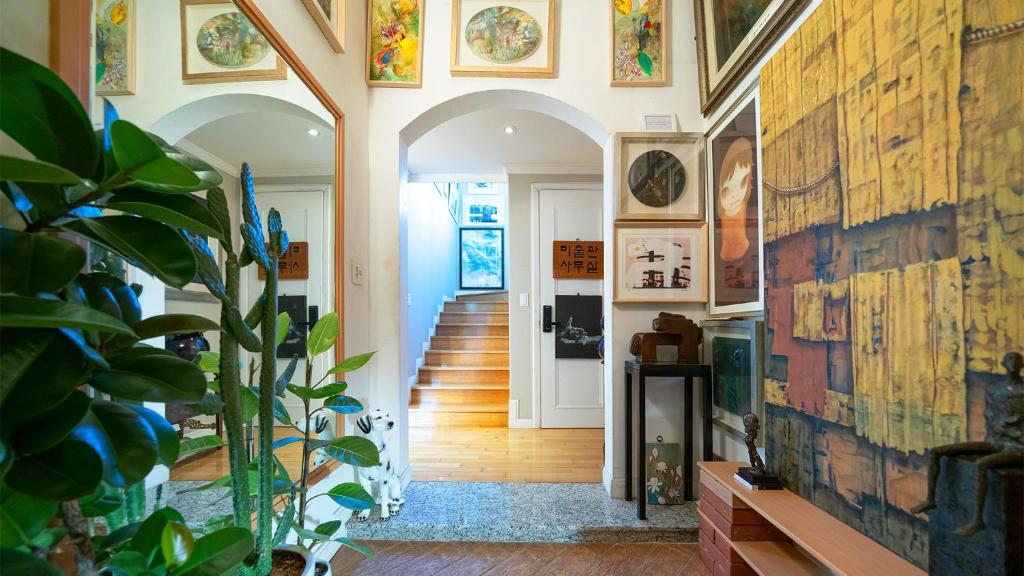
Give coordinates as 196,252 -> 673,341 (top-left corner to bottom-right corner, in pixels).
366,0 -> 426,88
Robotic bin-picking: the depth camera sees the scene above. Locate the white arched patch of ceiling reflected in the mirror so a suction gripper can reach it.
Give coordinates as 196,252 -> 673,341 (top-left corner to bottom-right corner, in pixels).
182,112 -> 334,176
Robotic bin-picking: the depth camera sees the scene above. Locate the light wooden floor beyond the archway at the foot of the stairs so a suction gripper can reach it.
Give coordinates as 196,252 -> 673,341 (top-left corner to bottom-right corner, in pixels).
409,427 -> 604,483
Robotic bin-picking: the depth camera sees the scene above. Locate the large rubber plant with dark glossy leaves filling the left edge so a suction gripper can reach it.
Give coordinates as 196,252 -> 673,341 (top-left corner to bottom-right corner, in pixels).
0,48 -> 254,576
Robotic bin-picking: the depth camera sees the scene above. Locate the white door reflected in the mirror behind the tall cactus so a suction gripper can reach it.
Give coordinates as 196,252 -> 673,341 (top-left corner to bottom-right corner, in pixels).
242,187 -> 334,422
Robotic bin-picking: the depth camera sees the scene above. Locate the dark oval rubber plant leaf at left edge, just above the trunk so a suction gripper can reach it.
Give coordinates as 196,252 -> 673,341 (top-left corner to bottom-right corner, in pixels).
4,439 -> 103,500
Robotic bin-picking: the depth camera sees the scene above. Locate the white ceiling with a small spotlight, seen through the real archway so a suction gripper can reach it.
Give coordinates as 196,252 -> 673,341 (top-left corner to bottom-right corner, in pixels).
409,110 -> 602,177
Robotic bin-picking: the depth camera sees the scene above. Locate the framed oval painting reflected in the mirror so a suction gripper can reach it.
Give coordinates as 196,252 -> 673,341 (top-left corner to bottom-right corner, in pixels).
181,0 -> 288,84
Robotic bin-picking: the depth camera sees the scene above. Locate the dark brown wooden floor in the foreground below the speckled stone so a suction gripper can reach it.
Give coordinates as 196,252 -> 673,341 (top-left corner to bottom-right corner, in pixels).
331,541 -> 710,576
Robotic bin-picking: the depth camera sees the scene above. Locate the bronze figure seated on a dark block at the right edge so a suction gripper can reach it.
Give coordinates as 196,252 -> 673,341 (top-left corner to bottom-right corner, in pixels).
911,352 -> 1024,537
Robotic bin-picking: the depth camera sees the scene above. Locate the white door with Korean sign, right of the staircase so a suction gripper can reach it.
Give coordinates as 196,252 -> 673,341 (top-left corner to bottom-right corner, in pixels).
538,183 -> 604,428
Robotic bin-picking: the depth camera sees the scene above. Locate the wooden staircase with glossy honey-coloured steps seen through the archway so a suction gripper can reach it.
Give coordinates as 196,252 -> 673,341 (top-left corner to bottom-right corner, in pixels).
409,292 -> 509,427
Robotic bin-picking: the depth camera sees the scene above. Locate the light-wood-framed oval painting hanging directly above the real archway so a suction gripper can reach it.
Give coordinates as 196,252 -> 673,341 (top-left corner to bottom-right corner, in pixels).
452,0 -> 556,78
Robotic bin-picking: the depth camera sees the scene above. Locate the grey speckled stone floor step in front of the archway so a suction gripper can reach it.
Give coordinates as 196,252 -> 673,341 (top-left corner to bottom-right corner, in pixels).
347,482 -> 699,542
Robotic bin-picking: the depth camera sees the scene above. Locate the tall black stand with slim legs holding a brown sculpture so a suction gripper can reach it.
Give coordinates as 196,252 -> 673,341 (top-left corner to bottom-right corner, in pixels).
626,361 -> 713,520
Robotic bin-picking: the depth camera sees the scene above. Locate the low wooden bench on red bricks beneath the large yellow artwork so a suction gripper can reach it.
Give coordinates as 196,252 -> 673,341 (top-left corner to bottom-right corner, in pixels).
697,462 -> 926,576
